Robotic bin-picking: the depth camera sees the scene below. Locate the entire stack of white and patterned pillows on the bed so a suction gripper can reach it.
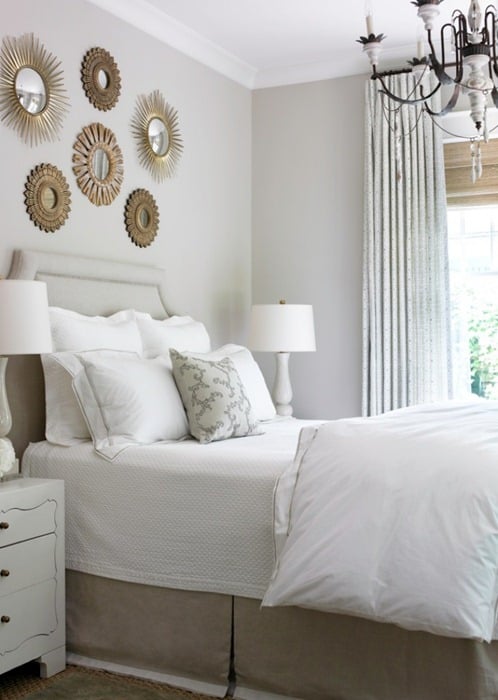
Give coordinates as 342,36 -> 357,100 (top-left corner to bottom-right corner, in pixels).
42,307 -> 275,460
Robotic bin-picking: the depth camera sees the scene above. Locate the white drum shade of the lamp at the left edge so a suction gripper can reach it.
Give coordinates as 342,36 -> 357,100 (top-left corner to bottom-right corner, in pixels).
0,279 -> 52,355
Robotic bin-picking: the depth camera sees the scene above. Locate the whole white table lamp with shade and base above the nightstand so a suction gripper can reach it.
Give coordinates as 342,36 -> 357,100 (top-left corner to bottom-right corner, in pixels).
0,279 -> 52,477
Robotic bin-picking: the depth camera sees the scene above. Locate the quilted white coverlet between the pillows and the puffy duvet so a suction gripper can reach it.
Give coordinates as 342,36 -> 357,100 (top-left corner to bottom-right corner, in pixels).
23,419 -> 320,598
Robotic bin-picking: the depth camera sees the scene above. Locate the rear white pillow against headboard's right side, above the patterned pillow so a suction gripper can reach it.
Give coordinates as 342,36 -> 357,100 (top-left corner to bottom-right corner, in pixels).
135,311 -> 211,361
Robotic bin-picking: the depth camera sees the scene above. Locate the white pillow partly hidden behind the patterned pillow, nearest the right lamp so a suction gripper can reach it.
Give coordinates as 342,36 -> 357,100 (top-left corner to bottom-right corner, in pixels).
184,343 -> 276,421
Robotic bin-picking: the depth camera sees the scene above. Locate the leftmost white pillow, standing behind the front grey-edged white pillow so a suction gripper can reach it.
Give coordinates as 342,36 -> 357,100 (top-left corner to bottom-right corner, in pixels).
41,350 -> 138,446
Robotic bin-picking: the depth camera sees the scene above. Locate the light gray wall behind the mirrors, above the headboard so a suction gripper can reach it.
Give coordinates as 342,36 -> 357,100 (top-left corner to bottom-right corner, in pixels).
0,0 -> 251,344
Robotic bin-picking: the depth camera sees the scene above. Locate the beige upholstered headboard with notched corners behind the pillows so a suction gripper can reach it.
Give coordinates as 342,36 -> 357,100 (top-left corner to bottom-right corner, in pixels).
7,250 -> 168,457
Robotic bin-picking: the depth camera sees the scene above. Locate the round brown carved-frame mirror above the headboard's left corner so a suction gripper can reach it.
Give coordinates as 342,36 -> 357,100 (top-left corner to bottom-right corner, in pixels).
24,163 -> 71,233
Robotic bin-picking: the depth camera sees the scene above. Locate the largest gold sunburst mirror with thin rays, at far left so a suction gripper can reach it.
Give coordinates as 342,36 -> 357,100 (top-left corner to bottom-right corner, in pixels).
0,34 -> 69,146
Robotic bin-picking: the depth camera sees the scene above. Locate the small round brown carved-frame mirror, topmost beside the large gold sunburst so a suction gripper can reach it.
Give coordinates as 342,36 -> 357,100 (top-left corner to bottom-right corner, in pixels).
81,46 -> 121,112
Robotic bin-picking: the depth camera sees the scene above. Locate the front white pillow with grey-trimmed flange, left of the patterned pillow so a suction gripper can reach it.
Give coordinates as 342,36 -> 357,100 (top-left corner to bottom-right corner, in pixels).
73,355 -> 188,460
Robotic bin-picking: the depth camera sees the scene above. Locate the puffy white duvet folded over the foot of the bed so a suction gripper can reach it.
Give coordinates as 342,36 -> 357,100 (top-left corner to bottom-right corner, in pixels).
263,400 -> 498,641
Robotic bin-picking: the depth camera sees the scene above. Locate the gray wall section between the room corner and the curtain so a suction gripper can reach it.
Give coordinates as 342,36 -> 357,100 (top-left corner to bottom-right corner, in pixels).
252,76 -> 365,418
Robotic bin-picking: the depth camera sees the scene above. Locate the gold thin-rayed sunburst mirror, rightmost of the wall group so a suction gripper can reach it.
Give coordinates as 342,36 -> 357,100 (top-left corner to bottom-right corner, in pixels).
131,90 -> 183,182
